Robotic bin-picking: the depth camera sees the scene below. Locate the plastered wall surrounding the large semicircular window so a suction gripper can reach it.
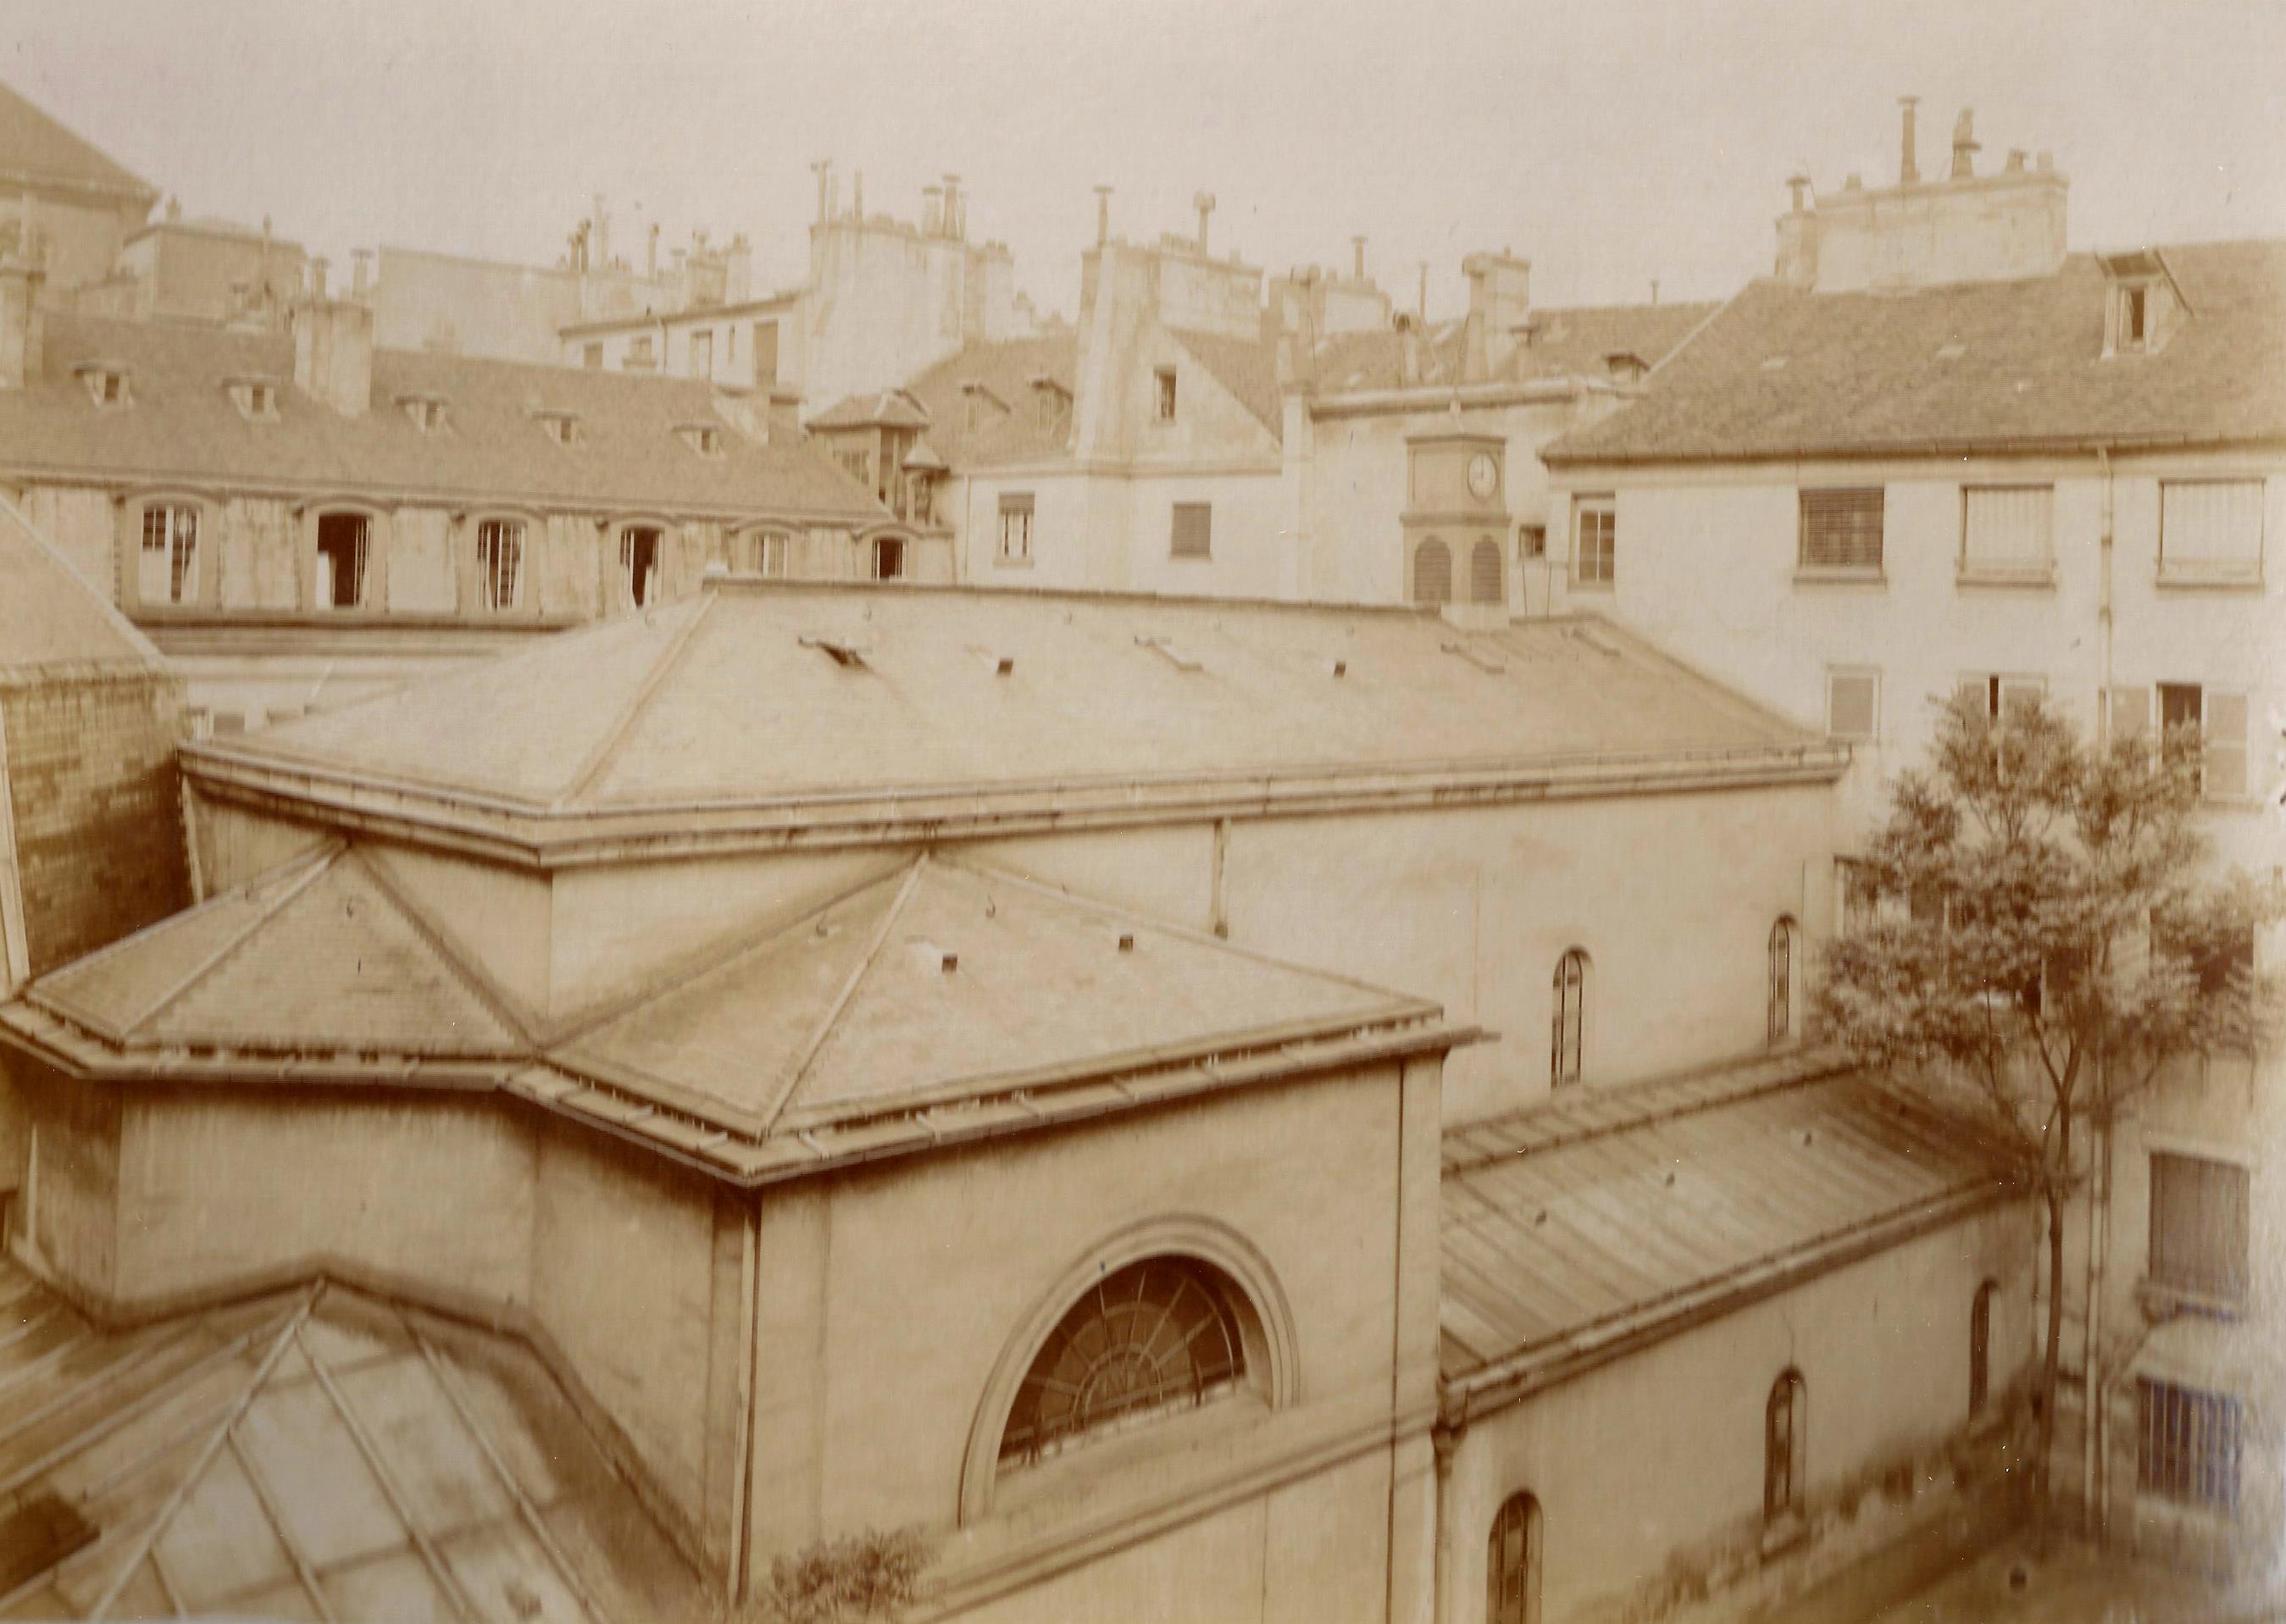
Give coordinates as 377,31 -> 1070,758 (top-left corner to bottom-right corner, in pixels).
752,1062 -> 1438,1620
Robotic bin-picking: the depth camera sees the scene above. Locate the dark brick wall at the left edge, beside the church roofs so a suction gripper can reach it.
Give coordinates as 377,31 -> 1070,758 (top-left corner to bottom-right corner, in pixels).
0,672 -> 190,975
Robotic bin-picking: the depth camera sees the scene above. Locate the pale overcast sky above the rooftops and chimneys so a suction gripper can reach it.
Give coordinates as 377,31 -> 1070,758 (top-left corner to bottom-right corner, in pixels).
0,0 -> 2286,313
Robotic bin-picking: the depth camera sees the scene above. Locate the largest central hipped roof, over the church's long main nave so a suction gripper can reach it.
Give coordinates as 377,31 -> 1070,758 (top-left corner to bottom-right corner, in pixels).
186,580 -> 1831,839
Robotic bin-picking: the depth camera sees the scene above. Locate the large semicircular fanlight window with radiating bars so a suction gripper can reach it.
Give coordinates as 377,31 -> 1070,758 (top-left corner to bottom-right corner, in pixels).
999,1256 -> 1248,1469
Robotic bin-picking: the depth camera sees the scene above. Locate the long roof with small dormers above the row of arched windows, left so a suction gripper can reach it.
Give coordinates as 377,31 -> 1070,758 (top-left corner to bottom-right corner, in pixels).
0,313 -> 887,521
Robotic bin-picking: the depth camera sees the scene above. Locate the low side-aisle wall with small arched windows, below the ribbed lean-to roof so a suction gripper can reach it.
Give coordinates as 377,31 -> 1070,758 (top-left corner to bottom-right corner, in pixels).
1442,1208 -> 2033,1624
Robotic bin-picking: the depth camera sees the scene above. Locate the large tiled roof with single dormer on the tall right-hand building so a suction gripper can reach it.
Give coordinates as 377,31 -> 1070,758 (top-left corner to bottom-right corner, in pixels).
1545,242 -> 2286,463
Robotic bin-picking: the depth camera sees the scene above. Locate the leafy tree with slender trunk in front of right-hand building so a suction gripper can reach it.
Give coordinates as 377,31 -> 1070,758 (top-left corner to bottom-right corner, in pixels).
1811,695 -> 2286,1503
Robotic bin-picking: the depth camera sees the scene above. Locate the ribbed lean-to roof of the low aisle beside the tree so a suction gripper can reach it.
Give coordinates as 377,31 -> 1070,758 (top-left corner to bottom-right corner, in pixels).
1440,1056 -> 2017,1410
